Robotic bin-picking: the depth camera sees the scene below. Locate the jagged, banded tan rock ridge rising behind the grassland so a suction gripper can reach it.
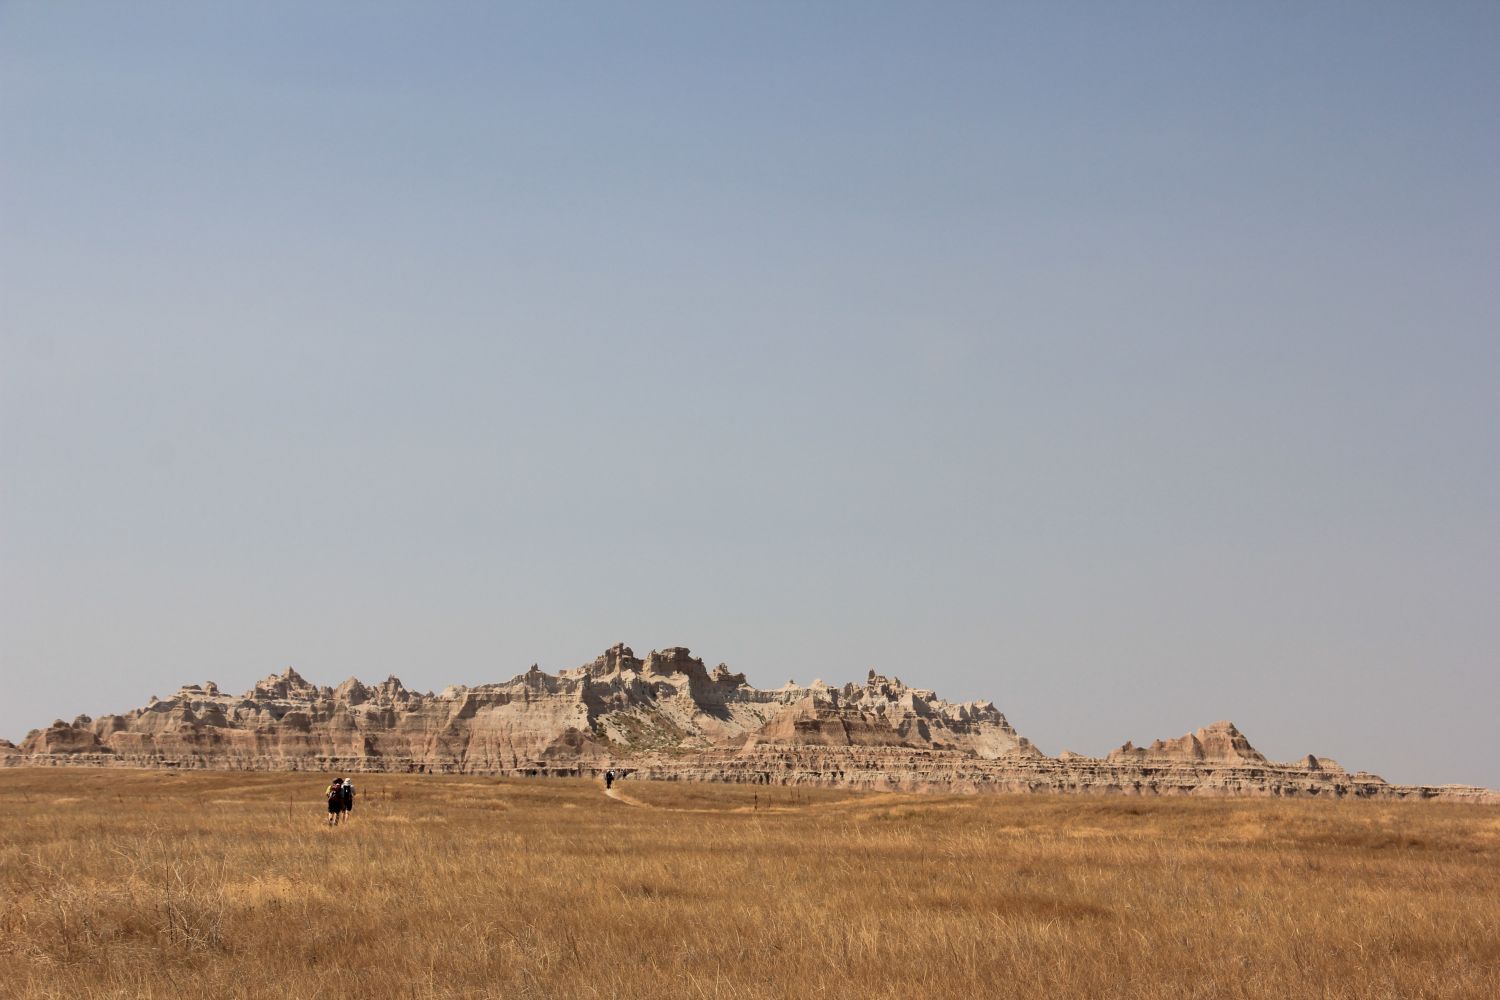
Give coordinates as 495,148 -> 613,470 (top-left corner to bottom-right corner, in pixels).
0,645 -> 1500,802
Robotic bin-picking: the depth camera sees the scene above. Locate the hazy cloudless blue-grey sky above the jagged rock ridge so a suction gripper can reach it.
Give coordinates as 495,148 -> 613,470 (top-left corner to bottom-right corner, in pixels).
0,0 -> 1500,787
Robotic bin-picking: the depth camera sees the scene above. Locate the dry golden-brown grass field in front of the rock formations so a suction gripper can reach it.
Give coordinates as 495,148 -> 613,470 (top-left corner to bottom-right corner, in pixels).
0,769 -> 1500,1000
